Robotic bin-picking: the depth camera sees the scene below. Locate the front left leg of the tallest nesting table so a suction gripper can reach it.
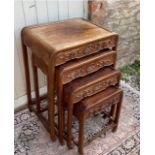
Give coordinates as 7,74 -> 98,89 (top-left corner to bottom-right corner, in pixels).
47,68 -> 55,141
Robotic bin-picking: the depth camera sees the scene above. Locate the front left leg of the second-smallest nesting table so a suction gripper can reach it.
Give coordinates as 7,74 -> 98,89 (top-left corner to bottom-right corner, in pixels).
67,101 -> 73,149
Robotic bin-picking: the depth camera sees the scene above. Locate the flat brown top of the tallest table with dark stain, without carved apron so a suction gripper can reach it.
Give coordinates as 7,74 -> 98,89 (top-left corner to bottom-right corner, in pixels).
22,19 -> 116,52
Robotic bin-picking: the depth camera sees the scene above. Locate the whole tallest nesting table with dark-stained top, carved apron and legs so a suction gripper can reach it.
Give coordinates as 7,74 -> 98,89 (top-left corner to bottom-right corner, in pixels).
22,19 -> 118,141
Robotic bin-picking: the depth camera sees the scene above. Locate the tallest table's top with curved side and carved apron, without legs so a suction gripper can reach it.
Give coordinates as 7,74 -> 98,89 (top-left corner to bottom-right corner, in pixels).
22,19 -> 118,65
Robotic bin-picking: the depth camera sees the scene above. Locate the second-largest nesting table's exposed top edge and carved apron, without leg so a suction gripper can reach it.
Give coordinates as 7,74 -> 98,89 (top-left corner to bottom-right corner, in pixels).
56,50 -> 116,84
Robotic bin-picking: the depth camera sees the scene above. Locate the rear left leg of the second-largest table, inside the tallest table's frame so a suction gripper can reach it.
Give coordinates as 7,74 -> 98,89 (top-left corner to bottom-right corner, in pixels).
32,57 -> 40,112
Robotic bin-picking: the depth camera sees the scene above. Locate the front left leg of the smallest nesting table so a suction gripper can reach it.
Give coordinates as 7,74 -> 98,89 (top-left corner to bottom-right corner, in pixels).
78,116 -> 84,154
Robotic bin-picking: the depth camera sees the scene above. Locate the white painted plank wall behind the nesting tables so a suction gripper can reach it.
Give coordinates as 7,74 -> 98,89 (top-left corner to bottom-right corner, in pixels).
14,0 -> 87,107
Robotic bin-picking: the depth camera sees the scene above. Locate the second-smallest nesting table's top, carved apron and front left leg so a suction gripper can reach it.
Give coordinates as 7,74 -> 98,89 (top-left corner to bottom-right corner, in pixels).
63,67 -> 120,148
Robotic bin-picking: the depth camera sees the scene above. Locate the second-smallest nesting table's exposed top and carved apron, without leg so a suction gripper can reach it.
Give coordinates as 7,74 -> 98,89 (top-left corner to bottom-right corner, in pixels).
64,67 -> 120,104
